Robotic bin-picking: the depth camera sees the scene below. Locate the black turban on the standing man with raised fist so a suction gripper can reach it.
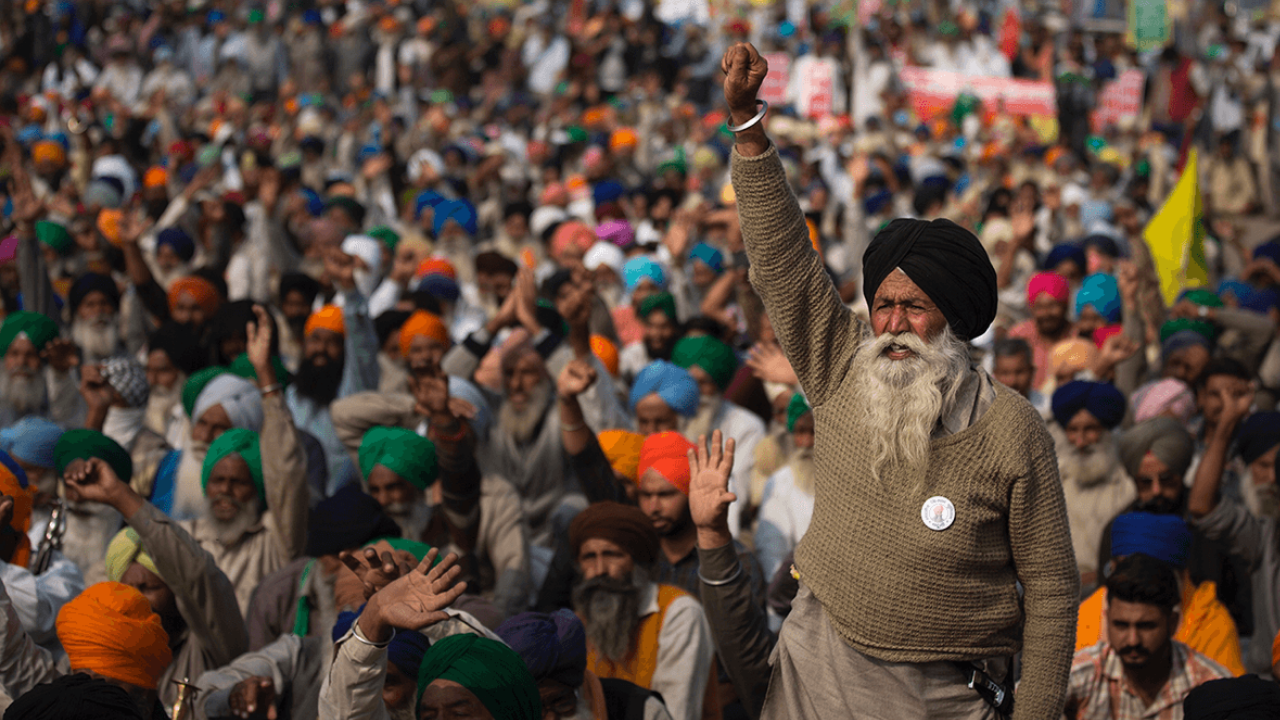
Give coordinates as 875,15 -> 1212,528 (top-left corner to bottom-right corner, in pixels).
863,218 -> 996,341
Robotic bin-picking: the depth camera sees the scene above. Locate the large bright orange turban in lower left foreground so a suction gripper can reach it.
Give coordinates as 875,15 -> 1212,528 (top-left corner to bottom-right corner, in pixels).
58,583 -> 173,689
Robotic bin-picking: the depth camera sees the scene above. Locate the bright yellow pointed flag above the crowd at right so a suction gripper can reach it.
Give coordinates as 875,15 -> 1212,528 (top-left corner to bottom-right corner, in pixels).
1142,149 -> 1208,305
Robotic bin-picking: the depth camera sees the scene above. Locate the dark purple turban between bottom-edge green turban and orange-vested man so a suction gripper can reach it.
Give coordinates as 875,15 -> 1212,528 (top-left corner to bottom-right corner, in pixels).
498,607 -> 586,688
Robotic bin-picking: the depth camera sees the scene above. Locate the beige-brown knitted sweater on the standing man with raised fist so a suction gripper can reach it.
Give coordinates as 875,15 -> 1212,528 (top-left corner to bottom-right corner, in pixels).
732,147 -> 1079,720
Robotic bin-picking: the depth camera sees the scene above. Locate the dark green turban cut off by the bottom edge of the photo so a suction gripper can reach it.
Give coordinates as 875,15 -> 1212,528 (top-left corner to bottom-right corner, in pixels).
413,634 -> 543,720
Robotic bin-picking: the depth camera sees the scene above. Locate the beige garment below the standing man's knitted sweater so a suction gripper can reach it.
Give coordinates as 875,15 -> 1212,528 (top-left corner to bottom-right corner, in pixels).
760,582 -> 1009,720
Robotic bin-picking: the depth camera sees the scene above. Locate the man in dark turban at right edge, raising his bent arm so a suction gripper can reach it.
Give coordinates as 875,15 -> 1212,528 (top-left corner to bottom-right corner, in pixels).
1187,409 -> 1280,674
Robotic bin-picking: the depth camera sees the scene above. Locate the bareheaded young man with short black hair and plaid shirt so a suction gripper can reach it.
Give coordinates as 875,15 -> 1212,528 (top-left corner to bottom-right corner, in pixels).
1066,553 -> 1231,720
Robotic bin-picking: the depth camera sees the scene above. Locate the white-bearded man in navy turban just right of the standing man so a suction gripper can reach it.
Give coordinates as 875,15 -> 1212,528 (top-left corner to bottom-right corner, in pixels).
1048,380 -> 1135,588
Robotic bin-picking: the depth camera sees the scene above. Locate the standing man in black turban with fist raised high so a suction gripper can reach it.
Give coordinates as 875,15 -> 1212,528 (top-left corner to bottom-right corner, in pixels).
727,44 -> 1079,720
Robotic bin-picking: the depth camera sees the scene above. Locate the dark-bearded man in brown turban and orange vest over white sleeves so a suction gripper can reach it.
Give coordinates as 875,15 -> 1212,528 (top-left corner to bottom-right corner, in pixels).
570,499 -> 721,720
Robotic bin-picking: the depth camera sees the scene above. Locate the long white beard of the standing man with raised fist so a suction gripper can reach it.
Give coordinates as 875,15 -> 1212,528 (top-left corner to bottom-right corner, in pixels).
850,325 -> 969,480
